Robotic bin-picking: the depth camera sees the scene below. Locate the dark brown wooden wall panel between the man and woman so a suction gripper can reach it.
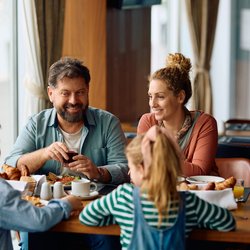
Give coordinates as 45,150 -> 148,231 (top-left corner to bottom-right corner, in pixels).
107,8 -> 151,122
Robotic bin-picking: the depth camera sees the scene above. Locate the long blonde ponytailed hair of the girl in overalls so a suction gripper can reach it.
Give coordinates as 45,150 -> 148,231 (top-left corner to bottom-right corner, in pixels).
126,127 -> 182,225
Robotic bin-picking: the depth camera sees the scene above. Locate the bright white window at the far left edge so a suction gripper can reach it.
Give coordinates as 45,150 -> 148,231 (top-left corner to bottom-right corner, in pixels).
0,0 -> 17,162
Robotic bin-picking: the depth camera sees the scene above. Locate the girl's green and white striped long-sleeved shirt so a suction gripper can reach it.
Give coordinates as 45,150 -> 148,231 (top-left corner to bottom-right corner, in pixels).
79,183 -> 235,249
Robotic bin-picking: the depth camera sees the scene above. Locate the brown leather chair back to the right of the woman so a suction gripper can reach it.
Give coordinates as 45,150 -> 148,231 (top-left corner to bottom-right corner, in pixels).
215,158 -> 250,187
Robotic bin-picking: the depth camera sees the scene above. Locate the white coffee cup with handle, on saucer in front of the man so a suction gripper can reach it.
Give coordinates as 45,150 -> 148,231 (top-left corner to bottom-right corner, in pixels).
71,179 -> 97,197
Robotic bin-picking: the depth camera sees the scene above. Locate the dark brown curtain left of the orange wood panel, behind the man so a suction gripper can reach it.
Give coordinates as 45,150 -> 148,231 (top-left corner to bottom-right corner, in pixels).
35,0 -> 65,107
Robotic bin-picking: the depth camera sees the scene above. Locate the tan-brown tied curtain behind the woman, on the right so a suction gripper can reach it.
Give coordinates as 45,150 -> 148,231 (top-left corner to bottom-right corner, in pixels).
186,0 -> 219,114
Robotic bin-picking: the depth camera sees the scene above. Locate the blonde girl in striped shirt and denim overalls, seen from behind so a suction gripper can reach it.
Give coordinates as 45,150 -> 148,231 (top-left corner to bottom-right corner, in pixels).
79,126 -> 235,250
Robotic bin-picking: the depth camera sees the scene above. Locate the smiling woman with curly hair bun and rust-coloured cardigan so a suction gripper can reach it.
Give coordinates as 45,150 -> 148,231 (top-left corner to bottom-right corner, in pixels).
137,53 -> 218,176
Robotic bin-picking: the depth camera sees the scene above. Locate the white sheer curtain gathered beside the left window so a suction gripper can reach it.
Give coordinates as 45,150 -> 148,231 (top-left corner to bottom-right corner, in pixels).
22,0 -> 47,119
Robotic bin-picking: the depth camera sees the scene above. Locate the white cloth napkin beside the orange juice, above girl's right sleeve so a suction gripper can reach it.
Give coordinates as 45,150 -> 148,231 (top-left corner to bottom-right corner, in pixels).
189,188 -> 237,210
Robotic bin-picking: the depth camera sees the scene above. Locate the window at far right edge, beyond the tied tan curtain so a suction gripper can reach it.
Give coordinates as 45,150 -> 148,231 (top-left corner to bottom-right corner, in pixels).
231,1 -> 250,119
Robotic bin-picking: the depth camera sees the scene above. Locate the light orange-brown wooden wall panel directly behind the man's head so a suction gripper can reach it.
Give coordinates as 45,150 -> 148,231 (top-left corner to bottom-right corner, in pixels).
63,0 -> 107,109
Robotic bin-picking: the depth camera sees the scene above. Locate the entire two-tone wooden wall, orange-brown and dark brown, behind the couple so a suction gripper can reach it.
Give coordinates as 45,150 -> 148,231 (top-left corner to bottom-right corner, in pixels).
63,0 -> 151,122
